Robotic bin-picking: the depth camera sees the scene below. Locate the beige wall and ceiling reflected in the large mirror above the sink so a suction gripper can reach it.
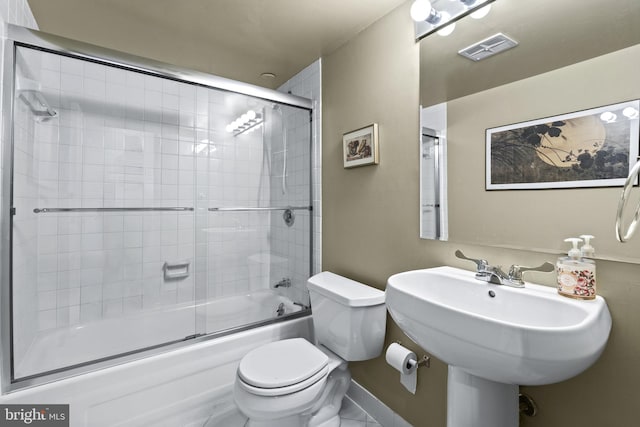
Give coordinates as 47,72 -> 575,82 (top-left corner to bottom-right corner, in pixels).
420,0 -> 640,263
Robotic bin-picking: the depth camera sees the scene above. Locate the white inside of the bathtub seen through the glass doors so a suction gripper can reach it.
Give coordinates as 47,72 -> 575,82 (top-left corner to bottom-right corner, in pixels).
15,290 -> 302,378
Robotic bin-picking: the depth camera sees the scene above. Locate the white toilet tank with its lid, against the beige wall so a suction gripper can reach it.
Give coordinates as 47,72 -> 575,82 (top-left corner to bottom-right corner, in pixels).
307,271 -> 387,361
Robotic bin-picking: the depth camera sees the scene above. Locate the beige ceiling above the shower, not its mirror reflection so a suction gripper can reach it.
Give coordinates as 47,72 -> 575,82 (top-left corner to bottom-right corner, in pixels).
28,0 -> 406,88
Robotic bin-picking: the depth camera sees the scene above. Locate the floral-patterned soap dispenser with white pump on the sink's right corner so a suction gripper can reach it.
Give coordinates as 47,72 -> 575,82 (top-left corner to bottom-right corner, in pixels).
556,236 -> 596,299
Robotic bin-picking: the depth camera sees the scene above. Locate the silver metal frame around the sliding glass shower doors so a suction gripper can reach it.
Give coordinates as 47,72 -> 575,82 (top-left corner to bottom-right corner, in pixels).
0,25 -> 313,392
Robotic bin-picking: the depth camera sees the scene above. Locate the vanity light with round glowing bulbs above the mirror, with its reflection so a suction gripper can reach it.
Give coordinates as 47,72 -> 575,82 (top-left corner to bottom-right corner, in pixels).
410,0 -> 495,41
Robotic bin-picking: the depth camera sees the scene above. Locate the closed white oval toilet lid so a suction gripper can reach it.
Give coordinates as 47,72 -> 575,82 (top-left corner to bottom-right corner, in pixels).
238,338 -> 329,388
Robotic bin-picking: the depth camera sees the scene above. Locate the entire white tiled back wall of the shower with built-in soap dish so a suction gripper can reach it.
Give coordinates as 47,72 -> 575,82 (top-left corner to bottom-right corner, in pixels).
14,45 -> 270,342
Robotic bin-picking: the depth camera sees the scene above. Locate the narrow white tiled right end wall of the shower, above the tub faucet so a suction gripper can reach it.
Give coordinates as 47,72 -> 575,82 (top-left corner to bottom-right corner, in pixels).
271,59 -> 322,301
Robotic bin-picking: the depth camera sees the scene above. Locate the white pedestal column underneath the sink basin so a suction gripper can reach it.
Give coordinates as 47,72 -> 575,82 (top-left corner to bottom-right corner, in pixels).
447,365 -> 519,427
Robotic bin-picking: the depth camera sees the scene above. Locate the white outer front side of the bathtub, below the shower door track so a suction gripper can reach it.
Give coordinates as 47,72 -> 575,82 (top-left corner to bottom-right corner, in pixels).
0,313 -> 312,427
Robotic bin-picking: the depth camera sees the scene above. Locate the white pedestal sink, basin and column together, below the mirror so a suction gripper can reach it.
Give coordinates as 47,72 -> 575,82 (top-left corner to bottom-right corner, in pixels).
386,267 -> 611,427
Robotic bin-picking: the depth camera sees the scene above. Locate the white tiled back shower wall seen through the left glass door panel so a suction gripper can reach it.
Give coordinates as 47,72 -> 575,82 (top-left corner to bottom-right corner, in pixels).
16,51 -> 208,331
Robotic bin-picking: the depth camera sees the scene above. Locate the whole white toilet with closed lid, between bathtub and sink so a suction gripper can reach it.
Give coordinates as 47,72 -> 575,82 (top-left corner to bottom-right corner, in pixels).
233,271 -> 386,427
